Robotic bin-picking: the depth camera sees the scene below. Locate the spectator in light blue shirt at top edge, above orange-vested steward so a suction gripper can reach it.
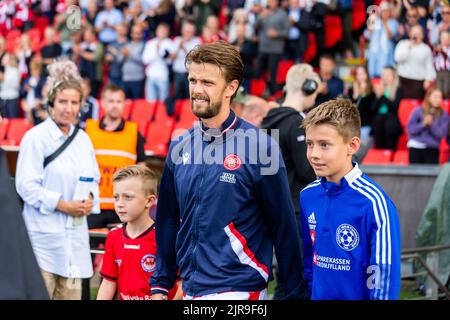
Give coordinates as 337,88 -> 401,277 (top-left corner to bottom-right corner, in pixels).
95,0 -> 124,45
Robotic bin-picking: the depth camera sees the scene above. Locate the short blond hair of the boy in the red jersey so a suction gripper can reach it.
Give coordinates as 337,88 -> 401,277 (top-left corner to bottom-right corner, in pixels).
113,165 -> 158,195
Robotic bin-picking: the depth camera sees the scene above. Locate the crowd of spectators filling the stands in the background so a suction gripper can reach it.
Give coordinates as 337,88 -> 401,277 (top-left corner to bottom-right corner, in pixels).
0,0 -> 450,160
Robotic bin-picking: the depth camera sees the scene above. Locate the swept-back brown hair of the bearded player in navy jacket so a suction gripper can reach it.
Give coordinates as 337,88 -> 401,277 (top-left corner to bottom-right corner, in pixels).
185,40 -> 244,100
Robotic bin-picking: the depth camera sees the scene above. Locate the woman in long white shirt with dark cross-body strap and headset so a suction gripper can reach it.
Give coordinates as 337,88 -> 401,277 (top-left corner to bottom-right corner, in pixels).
16,60 -> 100,300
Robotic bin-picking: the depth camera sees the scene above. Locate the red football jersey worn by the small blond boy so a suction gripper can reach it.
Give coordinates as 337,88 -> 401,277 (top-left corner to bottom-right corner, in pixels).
100,224 -> 177,300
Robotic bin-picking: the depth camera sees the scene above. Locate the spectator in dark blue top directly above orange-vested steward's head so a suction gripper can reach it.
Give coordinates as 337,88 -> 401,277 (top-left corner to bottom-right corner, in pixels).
105,23 -> 128,87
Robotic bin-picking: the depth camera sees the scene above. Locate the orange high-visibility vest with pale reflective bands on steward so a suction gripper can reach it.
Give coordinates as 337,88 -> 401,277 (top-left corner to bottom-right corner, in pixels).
86,119 -> 138,210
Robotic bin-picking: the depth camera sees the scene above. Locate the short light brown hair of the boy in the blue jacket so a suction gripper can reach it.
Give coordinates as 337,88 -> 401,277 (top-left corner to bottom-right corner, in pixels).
301,99 -> 361,141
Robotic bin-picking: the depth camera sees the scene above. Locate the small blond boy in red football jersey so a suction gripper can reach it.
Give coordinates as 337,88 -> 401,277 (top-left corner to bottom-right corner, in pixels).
97,165 -> 181,300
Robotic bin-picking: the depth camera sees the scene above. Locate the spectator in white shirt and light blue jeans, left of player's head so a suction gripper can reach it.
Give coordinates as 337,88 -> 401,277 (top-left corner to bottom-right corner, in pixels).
142,23 -> 174,101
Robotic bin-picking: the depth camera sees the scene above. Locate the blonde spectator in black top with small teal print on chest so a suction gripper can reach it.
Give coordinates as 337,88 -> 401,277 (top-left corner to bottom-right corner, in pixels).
372,67 -> 403,151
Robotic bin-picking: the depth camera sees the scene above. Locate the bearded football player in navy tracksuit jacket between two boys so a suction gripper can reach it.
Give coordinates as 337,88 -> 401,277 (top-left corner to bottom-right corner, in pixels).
151,41 -> 303,300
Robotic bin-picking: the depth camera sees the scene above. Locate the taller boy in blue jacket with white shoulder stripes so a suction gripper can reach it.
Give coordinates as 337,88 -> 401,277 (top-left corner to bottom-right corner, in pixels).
300,99 -> 400,300
